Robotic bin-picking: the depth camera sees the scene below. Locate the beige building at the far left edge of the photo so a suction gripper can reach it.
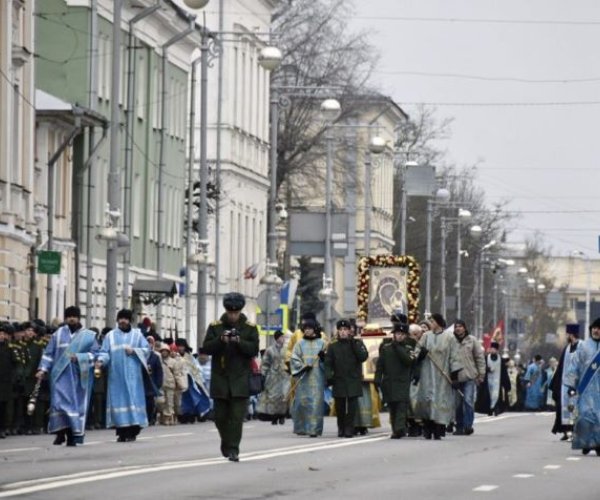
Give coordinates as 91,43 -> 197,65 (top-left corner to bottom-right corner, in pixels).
0,0 -> 35,320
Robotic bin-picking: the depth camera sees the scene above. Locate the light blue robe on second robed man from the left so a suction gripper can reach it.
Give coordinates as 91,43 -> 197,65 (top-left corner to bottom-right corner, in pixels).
98,328 -> 150,428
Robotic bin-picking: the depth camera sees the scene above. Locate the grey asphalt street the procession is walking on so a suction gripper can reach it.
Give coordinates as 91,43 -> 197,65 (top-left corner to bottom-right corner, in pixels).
0,413 -> 600,500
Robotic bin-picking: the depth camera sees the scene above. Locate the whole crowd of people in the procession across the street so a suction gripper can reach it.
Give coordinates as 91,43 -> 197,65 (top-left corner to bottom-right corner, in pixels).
0,292 -> 600,462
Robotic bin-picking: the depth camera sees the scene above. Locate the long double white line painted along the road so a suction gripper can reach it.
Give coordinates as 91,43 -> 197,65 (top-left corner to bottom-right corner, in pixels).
0,433 -> 389,498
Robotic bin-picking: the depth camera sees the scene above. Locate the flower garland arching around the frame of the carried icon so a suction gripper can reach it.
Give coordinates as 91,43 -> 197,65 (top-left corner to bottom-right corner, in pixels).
357,255 -> 420,323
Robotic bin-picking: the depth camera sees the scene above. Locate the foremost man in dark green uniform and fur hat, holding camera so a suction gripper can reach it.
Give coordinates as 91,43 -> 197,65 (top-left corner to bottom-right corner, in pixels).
202,292 -> 258,462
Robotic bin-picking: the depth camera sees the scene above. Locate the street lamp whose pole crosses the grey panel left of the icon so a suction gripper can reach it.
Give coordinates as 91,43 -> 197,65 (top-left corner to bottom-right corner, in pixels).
321,99 -> 341,329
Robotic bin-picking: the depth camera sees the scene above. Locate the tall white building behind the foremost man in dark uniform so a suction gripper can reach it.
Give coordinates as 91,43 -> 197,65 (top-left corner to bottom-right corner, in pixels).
186,0 -> 277,332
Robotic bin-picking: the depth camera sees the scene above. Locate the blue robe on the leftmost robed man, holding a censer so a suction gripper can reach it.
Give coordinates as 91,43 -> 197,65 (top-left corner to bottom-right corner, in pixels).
39,325 -> 98,443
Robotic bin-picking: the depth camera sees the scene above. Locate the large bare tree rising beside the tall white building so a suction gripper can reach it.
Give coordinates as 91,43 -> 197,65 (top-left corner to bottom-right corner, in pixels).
273,0 -> 378,200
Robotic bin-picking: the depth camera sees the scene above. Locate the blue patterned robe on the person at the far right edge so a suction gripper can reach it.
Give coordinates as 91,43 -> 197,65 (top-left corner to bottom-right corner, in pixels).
564,338 -> 600,450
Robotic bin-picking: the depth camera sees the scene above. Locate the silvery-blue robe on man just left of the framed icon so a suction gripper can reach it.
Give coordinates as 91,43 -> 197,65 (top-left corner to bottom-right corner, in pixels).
290,338 -> 325,436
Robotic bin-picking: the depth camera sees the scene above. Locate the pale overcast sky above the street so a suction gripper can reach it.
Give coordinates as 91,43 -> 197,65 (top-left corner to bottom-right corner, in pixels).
350,0 -> 600,259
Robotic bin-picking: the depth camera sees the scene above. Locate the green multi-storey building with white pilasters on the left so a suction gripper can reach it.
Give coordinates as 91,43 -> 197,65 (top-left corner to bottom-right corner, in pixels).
35,0 -> 200,335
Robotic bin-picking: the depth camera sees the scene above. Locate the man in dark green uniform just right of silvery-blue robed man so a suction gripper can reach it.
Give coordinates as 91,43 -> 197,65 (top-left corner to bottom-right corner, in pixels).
325,319 -> 369,437
